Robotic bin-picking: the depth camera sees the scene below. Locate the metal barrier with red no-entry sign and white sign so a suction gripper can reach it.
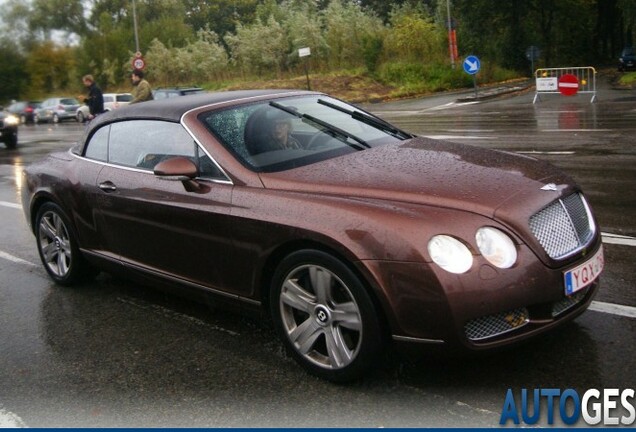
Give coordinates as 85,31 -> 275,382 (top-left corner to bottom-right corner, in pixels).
532,66 -> 596,104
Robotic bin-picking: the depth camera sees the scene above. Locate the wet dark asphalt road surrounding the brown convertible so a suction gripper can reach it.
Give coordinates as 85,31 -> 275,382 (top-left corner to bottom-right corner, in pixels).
0,77 -> 636,427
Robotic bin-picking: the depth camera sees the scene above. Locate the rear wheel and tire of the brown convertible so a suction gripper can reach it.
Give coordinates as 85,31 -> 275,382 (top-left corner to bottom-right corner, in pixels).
35,202 -> 96,286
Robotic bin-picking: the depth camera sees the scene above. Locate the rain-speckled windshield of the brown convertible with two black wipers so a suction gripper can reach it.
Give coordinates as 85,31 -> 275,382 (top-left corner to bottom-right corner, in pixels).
199,95 -> 412,172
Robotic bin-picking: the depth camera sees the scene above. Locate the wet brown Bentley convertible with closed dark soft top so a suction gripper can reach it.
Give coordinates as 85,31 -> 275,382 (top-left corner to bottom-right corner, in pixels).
21,90 -> 603,381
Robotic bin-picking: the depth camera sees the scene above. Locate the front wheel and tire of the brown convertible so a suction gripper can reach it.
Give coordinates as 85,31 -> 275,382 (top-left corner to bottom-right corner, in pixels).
270,250 -> 384,382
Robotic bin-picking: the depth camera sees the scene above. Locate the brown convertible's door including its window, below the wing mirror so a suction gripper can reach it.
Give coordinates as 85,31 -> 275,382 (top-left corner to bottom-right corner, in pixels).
97,120 -> 243,292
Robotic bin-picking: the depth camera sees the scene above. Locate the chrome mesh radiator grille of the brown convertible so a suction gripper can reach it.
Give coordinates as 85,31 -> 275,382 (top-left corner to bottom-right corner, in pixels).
530,193 -> 596,259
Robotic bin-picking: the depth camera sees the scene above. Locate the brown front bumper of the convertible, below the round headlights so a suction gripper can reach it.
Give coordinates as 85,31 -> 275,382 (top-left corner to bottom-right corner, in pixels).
366,238 -> 601,351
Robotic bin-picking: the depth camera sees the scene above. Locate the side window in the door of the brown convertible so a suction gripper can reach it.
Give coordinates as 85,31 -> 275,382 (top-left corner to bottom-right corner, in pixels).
108,120 -> 195,170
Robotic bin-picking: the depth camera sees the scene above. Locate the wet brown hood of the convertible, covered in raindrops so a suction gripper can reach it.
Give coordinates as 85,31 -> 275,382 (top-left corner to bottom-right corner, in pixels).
261,137 -> 573,217
